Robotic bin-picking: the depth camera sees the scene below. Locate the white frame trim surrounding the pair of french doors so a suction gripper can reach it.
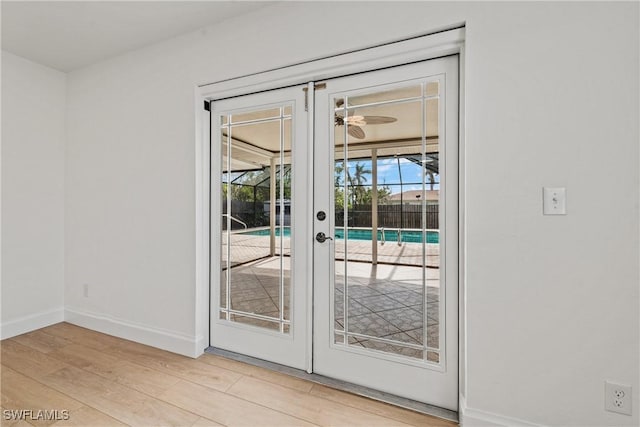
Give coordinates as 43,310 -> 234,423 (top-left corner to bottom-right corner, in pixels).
193,28 -> 466,395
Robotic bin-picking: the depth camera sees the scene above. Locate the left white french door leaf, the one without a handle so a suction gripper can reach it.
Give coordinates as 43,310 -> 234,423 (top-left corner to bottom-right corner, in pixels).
210,86 -> 311,369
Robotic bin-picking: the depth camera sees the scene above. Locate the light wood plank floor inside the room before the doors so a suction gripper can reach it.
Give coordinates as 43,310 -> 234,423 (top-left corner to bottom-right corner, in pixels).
0,323 -> 456,427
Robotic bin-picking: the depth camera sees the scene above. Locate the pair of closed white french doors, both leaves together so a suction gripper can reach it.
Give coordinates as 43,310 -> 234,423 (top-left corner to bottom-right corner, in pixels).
211,56 -> 458,410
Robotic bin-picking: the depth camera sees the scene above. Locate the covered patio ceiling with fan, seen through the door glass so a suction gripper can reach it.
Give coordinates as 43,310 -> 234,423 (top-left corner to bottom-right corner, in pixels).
221,85 -> 442,171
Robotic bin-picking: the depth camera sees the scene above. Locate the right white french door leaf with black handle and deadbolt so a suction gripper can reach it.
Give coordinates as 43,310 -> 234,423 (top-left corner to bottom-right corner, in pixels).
313,56 -> 458,410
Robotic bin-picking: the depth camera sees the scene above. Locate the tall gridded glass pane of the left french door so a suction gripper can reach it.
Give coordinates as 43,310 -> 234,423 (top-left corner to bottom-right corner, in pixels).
218,105 -> 293,334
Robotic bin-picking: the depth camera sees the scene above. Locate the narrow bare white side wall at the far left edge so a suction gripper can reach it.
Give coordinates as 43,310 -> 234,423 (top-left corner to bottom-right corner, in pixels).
1,51 -> 66,338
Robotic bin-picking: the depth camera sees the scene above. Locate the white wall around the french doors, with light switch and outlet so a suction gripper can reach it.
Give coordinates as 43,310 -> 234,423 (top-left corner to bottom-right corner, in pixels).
65,2 -> 640,425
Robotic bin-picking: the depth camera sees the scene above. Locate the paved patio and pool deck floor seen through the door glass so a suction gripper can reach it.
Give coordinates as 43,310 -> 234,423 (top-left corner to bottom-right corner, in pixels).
221,229 -> 440,361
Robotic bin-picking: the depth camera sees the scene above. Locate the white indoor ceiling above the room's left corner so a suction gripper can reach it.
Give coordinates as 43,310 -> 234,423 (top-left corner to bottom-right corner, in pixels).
0,0 -> 273,72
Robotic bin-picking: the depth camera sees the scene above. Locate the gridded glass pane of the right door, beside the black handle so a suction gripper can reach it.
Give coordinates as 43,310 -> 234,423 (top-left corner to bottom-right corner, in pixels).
333,80 -> 442,363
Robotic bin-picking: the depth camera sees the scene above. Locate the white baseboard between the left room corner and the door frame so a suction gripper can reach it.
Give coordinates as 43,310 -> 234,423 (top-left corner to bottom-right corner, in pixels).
64,307 -> 206,358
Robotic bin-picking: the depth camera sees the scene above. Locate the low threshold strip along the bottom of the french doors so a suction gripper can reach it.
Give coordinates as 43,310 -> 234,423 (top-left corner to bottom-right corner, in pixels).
205,347 -> 458,422
